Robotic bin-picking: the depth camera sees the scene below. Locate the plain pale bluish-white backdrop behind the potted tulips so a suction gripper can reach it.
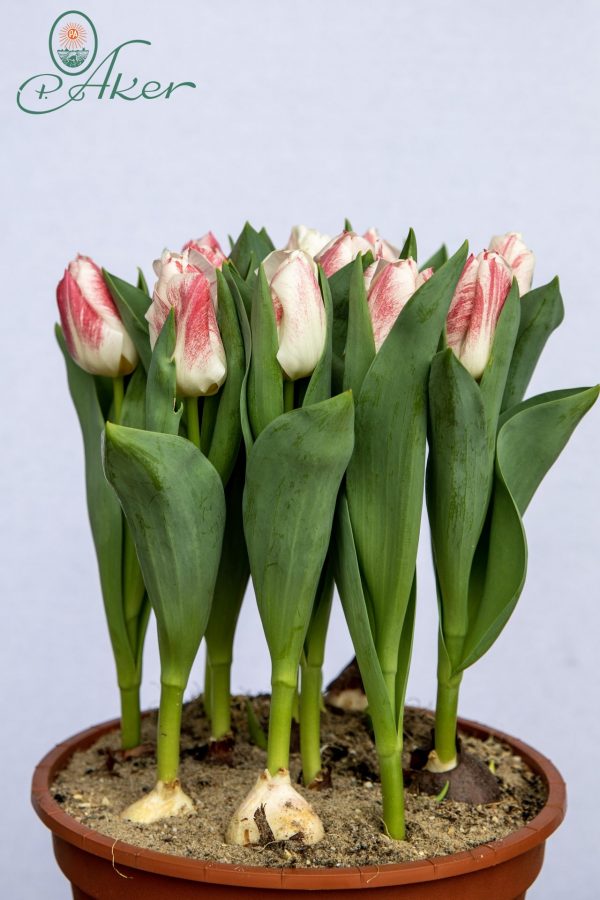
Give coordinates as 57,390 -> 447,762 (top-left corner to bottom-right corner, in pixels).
0,0 -> 600,900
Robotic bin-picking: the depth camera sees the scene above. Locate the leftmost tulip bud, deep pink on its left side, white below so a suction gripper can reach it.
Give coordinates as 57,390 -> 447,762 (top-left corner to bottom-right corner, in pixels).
56,255 -> 138,378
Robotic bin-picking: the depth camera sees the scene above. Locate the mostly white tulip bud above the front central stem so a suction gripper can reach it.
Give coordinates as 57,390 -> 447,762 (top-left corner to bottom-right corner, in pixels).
263,250 -> 327,381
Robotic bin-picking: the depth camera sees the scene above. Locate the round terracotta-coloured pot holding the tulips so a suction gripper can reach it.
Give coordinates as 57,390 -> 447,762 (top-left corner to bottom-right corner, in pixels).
32,720 -> 566,900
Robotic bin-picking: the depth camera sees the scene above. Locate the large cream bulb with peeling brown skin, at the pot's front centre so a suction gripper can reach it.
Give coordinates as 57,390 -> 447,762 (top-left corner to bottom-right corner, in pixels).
225,769 -> 325,847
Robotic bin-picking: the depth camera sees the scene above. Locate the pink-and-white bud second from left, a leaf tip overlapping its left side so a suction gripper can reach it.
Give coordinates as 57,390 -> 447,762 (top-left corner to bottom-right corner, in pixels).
146,250 -> 227,397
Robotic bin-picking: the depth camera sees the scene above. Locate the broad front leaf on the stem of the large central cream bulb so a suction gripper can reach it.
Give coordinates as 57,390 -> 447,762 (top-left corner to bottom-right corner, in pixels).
244,393 -> 354,678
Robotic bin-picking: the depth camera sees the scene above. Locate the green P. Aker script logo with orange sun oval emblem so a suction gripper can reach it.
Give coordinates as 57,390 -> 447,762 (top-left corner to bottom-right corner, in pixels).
17,9 -> 196,115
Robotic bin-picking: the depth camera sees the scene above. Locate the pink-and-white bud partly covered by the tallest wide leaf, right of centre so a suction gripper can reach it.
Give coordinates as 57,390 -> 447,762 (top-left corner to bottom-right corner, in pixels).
365,258 -> 433,352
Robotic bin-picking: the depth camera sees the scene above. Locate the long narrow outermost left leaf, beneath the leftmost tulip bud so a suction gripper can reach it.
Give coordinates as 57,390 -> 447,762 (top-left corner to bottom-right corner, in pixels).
56,325 -> 139,688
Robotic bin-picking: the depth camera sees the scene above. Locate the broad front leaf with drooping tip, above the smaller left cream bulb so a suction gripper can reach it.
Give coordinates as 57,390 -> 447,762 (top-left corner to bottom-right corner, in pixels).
104,423 -> 225,689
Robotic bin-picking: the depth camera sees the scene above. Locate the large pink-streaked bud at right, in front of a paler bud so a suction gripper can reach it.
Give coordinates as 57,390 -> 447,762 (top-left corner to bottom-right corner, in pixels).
446,250 -> 513,379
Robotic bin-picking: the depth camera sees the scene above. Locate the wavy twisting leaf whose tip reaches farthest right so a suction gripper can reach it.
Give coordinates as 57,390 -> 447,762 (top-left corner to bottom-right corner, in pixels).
460,387 -> 598,669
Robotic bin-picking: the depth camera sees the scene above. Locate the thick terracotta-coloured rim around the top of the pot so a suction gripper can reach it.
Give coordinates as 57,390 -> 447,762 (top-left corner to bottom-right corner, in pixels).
31,719 -> 566,890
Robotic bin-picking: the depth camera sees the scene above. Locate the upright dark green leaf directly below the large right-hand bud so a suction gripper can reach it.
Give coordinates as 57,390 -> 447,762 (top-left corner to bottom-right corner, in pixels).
427,348 -> 496,663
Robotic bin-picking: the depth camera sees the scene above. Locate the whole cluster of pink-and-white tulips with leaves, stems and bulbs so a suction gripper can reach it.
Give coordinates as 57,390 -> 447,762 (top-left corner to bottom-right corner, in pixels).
57,222 -> 598,844
